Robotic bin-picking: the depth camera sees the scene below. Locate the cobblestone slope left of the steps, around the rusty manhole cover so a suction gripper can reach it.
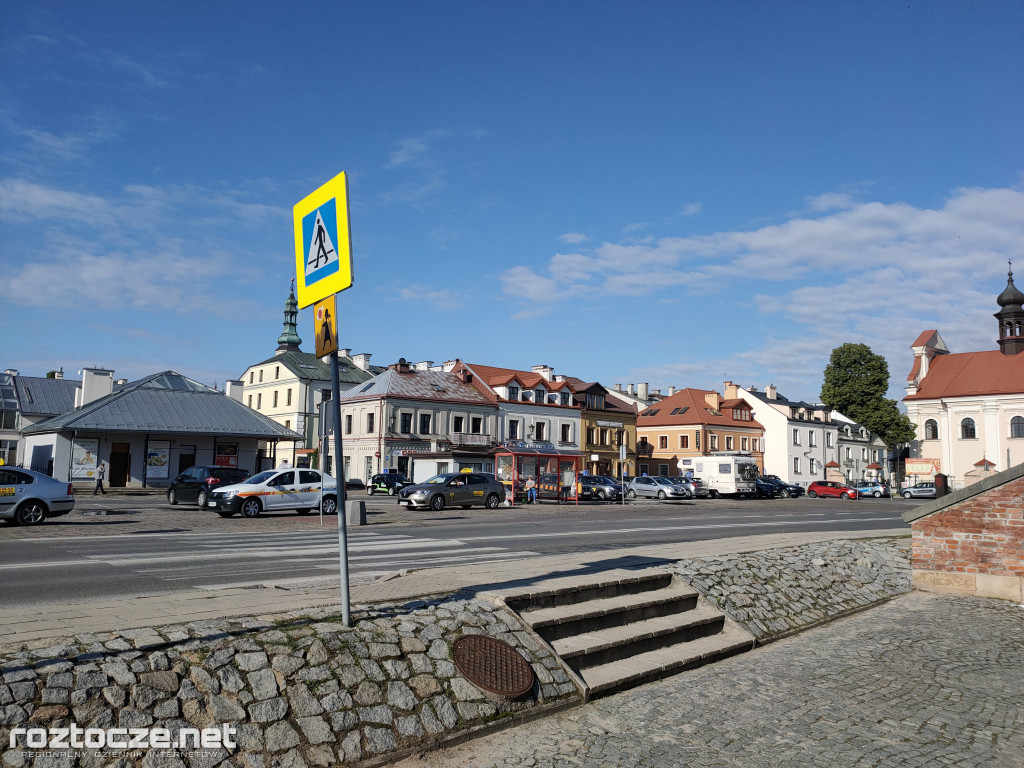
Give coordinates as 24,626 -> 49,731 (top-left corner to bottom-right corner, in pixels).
0,599 -> 582,768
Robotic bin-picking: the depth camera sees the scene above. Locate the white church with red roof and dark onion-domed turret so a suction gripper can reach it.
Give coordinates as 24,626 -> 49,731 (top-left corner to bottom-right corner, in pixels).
903,268 -> 1024,488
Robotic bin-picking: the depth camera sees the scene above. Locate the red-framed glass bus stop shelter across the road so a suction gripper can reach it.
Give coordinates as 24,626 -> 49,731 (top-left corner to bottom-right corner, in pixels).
494,443 -> 583,505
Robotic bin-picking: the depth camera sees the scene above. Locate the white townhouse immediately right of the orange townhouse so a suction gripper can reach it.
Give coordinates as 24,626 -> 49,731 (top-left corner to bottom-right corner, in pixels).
725,381 -> 839,487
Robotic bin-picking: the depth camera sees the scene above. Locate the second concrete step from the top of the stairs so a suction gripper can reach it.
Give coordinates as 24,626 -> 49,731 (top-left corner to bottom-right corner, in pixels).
519,582 -> 698,642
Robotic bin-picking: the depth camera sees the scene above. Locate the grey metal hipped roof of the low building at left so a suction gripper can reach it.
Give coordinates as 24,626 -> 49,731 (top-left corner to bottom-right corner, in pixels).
25,371 -> 302,440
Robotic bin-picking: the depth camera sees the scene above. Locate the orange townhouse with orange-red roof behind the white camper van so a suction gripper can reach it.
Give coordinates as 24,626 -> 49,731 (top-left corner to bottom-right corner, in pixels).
637,389 -> 765,476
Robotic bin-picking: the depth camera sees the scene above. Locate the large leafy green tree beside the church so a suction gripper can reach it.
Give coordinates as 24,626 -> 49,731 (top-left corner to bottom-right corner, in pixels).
821,344 -> 915,447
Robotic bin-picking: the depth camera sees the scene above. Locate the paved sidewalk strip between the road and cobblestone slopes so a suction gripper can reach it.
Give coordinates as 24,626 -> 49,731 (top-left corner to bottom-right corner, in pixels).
0,528 -> 900,650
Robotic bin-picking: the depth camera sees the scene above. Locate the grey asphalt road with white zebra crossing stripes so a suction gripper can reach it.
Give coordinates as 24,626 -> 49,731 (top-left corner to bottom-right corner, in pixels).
0,494 -> 920,607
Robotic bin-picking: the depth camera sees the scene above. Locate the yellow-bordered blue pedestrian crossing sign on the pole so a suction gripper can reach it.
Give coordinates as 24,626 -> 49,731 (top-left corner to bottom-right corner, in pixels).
293,173 -> 352,309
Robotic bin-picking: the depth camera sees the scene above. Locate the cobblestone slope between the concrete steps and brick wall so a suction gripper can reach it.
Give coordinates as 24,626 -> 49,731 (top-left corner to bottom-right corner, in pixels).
674,539 -> 911,642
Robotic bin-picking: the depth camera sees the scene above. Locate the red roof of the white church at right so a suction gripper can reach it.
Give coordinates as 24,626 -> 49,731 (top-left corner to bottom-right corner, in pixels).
903,350 -> 1024,400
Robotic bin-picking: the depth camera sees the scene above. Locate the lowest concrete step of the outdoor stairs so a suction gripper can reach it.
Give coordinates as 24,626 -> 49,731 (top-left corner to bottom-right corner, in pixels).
583,625 -> 754,696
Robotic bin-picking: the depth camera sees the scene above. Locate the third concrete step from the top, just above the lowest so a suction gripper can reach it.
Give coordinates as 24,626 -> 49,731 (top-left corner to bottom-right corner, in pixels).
551,605 -> 725,678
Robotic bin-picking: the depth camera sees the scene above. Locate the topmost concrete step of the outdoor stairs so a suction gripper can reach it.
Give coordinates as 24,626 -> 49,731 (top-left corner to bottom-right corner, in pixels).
502,569 -> 672,611
